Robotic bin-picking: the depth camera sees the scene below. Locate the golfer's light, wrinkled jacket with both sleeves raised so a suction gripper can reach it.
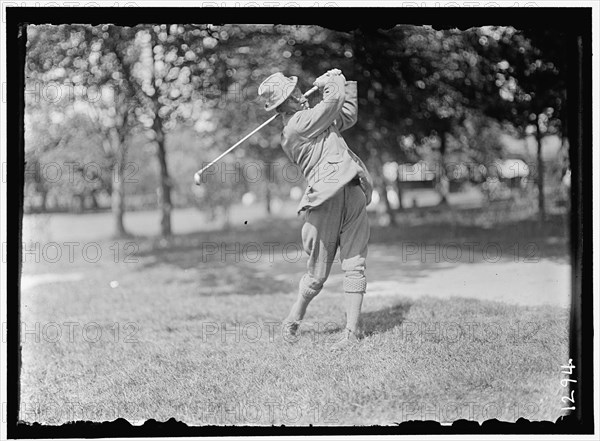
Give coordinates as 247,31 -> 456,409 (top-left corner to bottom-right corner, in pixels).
281,75 -> 373,213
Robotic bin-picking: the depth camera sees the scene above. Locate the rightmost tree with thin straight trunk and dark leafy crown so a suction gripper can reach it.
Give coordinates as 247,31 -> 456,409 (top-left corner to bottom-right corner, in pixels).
470,27 -> 567,222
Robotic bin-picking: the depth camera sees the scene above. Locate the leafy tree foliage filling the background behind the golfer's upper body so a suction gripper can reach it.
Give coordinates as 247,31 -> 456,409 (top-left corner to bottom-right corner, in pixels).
26,24 -> 566,229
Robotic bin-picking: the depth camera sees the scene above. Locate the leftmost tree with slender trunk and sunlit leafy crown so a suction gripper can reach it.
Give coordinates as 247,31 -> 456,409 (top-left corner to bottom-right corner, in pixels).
26,25 -> 136,236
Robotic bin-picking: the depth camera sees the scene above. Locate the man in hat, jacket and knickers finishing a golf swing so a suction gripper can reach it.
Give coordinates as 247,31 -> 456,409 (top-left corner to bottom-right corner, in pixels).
258,69 -> 373,350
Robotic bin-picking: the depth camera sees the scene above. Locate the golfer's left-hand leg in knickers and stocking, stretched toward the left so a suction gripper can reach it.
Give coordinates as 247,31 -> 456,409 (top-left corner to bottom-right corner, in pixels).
285,191 -> 343,332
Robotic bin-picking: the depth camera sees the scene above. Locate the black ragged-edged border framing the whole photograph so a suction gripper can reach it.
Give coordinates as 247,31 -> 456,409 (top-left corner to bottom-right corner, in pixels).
6,7 -> 594,439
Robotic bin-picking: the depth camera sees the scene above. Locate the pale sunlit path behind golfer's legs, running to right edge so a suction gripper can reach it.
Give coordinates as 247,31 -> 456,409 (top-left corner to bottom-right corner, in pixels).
264,245 -> 571,308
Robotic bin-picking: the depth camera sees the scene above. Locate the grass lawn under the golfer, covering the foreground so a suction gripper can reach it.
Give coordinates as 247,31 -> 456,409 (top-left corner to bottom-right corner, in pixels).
21,213 -> 568,425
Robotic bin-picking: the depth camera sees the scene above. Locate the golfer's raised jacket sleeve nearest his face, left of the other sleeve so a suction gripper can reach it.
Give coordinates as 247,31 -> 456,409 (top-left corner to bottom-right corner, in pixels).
294,75 -> 346,138
